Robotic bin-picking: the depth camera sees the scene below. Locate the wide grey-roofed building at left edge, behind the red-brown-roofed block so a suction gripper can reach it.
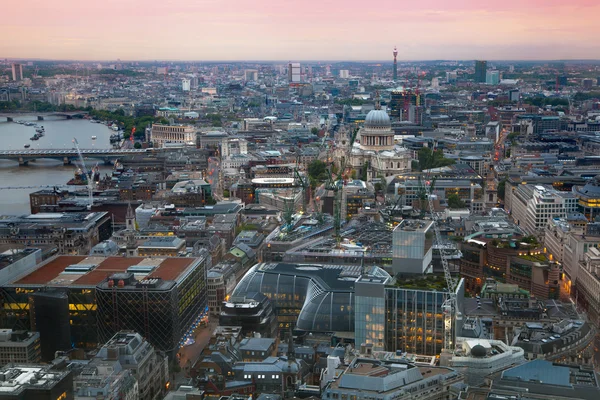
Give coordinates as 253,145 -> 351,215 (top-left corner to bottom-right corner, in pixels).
0,212 -> 112,255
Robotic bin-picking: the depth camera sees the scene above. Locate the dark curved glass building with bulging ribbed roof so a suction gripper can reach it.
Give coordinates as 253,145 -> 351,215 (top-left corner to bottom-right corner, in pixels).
232,263 -> 390,332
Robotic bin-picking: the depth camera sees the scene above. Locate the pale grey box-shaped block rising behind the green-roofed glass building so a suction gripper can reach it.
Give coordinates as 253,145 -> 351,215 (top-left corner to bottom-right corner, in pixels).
392,219 -> 434,275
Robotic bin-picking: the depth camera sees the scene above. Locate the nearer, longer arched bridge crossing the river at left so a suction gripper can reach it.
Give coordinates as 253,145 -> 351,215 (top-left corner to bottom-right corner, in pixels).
0,149 -> 149,165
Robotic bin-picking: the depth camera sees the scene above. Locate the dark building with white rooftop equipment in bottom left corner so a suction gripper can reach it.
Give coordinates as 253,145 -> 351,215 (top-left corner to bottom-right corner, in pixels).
0,364 -> 74,400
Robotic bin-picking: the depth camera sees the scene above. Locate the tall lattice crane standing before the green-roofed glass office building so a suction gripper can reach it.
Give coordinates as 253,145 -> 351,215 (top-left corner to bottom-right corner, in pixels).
426,181 -> 460,351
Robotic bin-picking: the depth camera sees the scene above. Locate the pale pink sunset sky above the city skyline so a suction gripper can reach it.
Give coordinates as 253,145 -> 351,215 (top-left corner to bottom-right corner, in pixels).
0,0 -> 600,61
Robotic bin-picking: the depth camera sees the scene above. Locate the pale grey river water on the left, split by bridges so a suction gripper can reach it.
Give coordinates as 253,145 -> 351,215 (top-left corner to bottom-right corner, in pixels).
0,114 -> 114,215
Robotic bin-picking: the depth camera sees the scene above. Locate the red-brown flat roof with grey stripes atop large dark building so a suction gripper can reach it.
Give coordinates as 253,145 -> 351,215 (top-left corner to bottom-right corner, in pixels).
8,256 -> 198,286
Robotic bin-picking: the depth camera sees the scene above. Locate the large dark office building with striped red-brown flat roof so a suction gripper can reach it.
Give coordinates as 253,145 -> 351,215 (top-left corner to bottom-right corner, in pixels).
0,253 -> 207,353
